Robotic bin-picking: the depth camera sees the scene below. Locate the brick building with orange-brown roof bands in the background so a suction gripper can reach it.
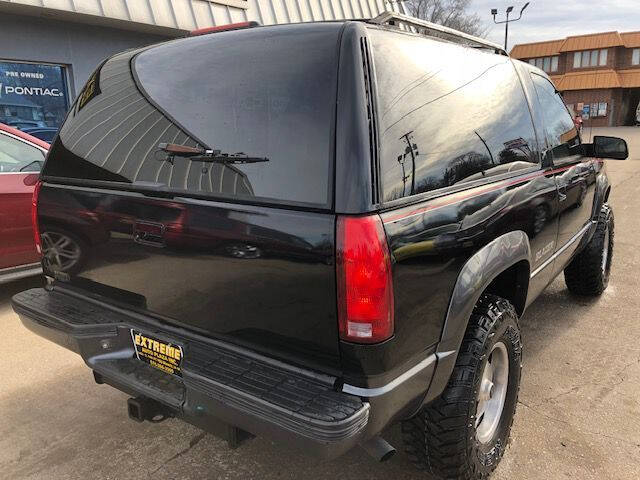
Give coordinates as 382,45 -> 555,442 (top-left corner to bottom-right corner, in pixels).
511,32 -> 640,127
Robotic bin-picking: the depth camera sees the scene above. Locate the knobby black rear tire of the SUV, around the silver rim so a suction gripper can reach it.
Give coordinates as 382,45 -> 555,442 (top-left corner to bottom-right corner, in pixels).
402,295 -> 522,480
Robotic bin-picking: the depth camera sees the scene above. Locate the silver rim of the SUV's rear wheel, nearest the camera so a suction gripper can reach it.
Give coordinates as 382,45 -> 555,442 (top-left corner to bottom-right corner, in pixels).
476,342 -> 509,443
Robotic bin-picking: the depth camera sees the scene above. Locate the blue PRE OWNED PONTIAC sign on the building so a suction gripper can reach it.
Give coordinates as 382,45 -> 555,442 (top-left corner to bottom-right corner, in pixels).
0,62 -> 69,131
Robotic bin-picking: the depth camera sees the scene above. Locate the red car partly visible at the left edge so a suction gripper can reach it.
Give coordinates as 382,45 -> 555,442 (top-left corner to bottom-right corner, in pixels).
0,123 -> 49,283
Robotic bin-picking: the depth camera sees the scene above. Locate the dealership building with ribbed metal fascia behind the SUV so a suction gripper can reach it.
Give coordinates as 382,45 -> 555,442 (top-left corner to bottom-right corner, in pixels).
0,0 -> 402,129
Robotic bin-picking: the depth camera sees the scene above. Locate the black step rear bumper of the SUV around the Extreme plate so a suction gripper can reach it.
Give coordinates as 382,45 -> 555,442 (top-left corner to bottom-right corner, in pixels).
12,288 -> 372,458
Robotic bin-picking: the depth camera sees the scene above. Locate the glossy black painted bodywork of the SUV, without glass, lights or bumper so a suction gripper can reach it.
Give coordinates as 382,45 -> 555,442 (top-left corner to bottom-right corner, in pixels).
16,22 -> 610,458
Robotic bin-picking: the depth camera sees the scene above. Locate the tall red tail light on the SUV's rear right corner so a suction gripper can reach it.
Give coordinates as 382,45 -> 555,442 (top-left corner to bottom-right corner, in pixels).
337,215 -> 393,343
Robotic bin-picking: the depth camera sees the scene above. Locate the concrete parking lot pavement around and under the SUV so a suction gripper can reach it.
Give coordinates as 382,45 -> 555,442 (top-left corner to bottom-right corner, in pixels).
0,127 -> 640,480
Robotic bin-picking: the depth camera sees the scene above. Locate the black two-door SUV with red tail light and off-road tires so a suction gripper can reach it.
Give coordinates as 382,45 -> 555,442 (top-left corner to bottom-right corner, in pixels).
13,14 -> 627,479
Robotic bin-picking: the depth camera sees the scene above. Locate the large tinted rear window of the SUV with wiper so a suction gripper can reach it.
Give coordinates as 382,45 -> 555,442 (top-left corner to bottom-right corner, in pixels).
44,24 -> 341,206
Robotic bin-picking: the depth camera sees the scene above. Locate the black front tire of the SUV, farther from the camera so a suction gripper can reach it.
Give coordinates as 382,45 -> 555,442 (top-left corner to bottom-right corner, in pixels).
564,203 -> 614,296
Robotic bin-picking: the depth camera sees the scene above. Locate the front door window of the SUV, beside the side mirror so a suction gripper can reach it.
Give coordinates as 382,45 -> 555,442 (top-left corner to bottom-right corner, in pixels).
531,73 -> 580,162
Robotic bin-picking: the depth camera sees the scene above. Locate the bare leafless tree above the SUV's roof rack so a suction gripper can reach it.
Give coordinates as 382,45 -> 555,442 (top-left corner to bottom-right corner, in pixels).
403,0 -> 487,37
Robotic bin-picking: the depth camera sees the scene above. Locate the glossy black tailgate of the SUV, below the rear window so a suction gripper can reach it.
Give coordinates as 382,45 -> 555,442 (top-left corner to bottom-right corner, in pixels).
38,184 -> 338,370
